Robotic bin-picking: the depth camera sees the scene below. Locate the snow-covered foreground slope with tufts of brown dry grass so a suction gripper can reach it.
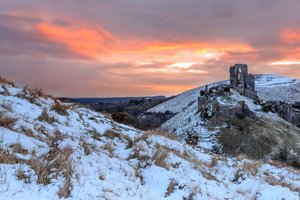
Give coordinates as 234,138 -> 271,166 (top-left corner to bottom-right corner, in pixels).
0,79 -> 300,200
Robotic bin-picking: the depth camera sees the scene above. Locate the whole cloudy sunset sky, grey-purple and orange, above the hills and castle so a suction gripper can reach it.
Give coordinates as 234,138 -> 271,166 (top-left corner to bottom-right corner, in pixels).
0,0 -> 300,97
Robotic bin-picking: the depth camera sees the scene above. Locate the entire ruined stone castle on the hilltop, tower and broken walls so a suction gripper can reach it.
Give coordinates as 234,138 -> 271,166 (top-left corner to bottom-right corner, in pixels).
198,64 -> 300,127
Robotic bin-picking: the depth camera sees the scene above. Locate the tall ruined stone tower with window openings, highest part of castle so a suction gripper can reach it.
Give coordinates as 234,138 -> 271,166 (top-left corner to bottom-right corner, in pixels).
229,64 -> 256,99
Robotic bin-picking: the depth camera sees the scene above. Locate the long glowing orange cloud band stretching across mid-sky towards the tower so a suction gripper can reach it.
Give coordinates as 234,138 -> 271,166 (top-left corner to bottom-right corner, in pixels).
38,23 -> 253,62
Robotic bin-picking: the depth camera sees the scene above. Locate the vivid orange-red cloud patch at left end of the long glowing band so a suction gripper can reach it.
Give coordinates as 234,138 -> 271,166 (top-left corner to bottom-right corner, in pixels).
38,23 -> 113,58
